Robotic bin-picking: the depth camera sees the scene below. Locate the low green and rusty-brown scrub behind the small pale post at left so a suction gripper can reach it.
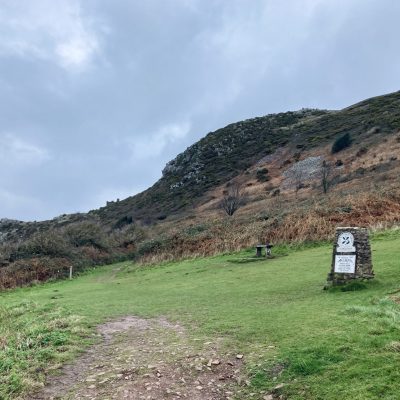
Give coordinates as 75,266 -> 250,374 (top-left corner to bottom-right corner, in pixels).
0,221 -> 145,290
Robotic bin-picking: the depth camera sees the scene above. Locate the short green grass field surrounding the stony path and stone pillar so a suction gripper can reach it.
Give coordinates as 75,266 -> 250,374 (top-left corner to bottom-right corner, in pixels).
0,232 -> 400,400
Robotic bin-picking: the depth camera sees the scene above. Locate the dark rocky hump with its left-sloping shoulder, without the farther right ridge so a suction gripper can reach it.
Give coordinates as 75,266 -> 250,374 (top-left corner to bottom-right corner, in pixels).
93,106 -> 328,222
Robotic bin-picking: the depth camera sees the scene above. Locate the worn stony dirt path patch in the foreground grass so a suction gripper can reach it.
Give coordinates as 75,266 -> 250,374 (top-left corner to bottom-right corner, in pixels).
29,317 -> 244,400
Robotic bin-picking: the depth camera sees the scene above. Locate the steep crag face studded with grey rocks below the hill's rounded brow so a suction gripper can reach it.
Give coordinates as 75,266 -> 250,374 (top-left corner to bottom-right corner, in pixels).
162,109 -> 329,191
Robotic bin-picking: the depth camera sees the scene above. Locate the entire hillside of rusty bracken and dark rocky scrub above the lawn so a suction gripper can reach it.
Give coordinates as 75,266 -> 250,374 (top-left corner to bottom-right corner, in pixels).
0,92 -> 400,288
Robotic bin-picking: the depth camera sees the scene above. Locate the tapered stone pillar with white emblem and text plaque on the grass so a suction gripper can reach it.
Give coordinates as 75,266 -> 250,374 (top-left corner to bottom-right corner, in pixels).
327,227 -> 374,286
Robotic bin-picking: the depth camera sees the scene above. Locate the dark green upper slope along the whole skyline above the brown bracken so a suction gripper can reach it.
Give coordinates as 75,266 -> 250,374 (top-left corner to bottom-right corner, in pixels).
91,92 -> 400,228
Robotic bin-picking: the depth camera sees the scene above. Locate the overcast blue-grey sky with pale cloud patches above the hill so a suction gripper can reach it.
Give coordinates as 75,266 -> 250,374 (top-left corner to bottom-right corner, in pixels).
0,0 -> 400,220
